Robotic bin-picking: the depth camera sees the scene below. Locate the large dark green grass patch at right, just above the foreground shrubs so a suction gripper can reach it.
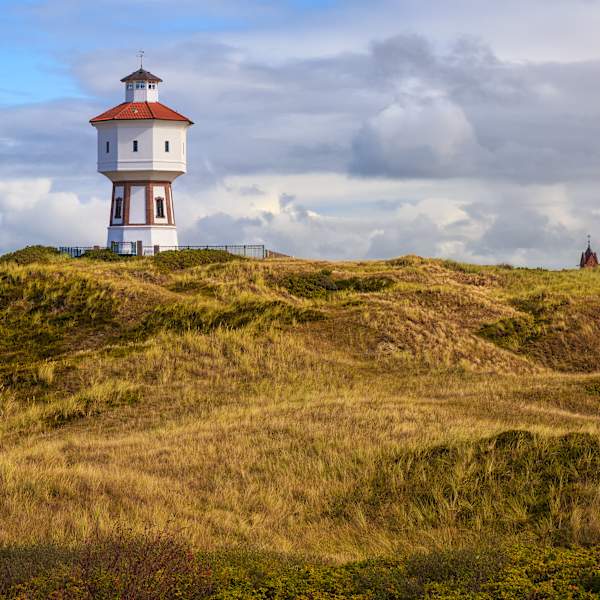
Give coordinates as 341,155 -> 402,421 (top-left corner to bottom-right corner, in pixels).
331,431 -> 600,543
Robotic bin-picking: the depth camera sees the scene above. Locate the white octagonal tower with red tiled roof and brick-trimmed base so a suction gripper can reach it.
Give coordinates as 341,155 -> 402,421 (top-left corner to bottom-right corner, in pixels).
90,61 -> 193,247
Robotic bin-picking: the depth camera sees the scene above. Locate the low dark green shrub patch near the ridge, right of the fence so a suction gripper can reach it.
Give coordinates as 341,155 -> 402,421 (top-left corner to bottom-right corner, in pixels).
275,269 -> 394,298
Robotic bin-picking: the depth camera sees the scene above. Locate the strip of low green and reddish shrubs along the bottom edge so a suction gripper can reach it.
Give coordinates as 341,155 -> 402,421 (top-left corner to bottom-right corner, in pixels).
0,533 -> 600,600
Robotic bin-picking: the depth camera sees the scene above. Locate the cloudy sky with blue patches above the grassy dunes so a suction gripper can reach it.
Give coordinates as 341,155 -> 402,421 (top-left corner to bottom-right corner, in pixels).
0,0 -> 600,268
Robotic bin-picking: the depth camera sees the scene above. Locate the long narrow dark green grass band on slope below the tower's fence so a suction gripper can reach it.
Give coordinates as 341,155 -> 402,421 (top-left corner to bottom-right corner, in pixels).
143,300 -> 324,333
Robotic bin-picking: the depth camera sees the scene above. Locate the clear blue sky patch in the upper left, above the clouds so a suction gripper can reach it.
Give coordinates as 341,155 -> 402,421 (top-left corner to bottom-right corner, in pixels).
0,0 -> 339,104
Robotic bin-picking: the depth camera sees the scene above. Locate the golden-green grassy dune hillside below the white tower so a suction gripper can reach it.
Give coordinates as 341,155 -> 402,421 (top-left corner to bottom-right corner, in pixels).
0,252 -> 600,598
